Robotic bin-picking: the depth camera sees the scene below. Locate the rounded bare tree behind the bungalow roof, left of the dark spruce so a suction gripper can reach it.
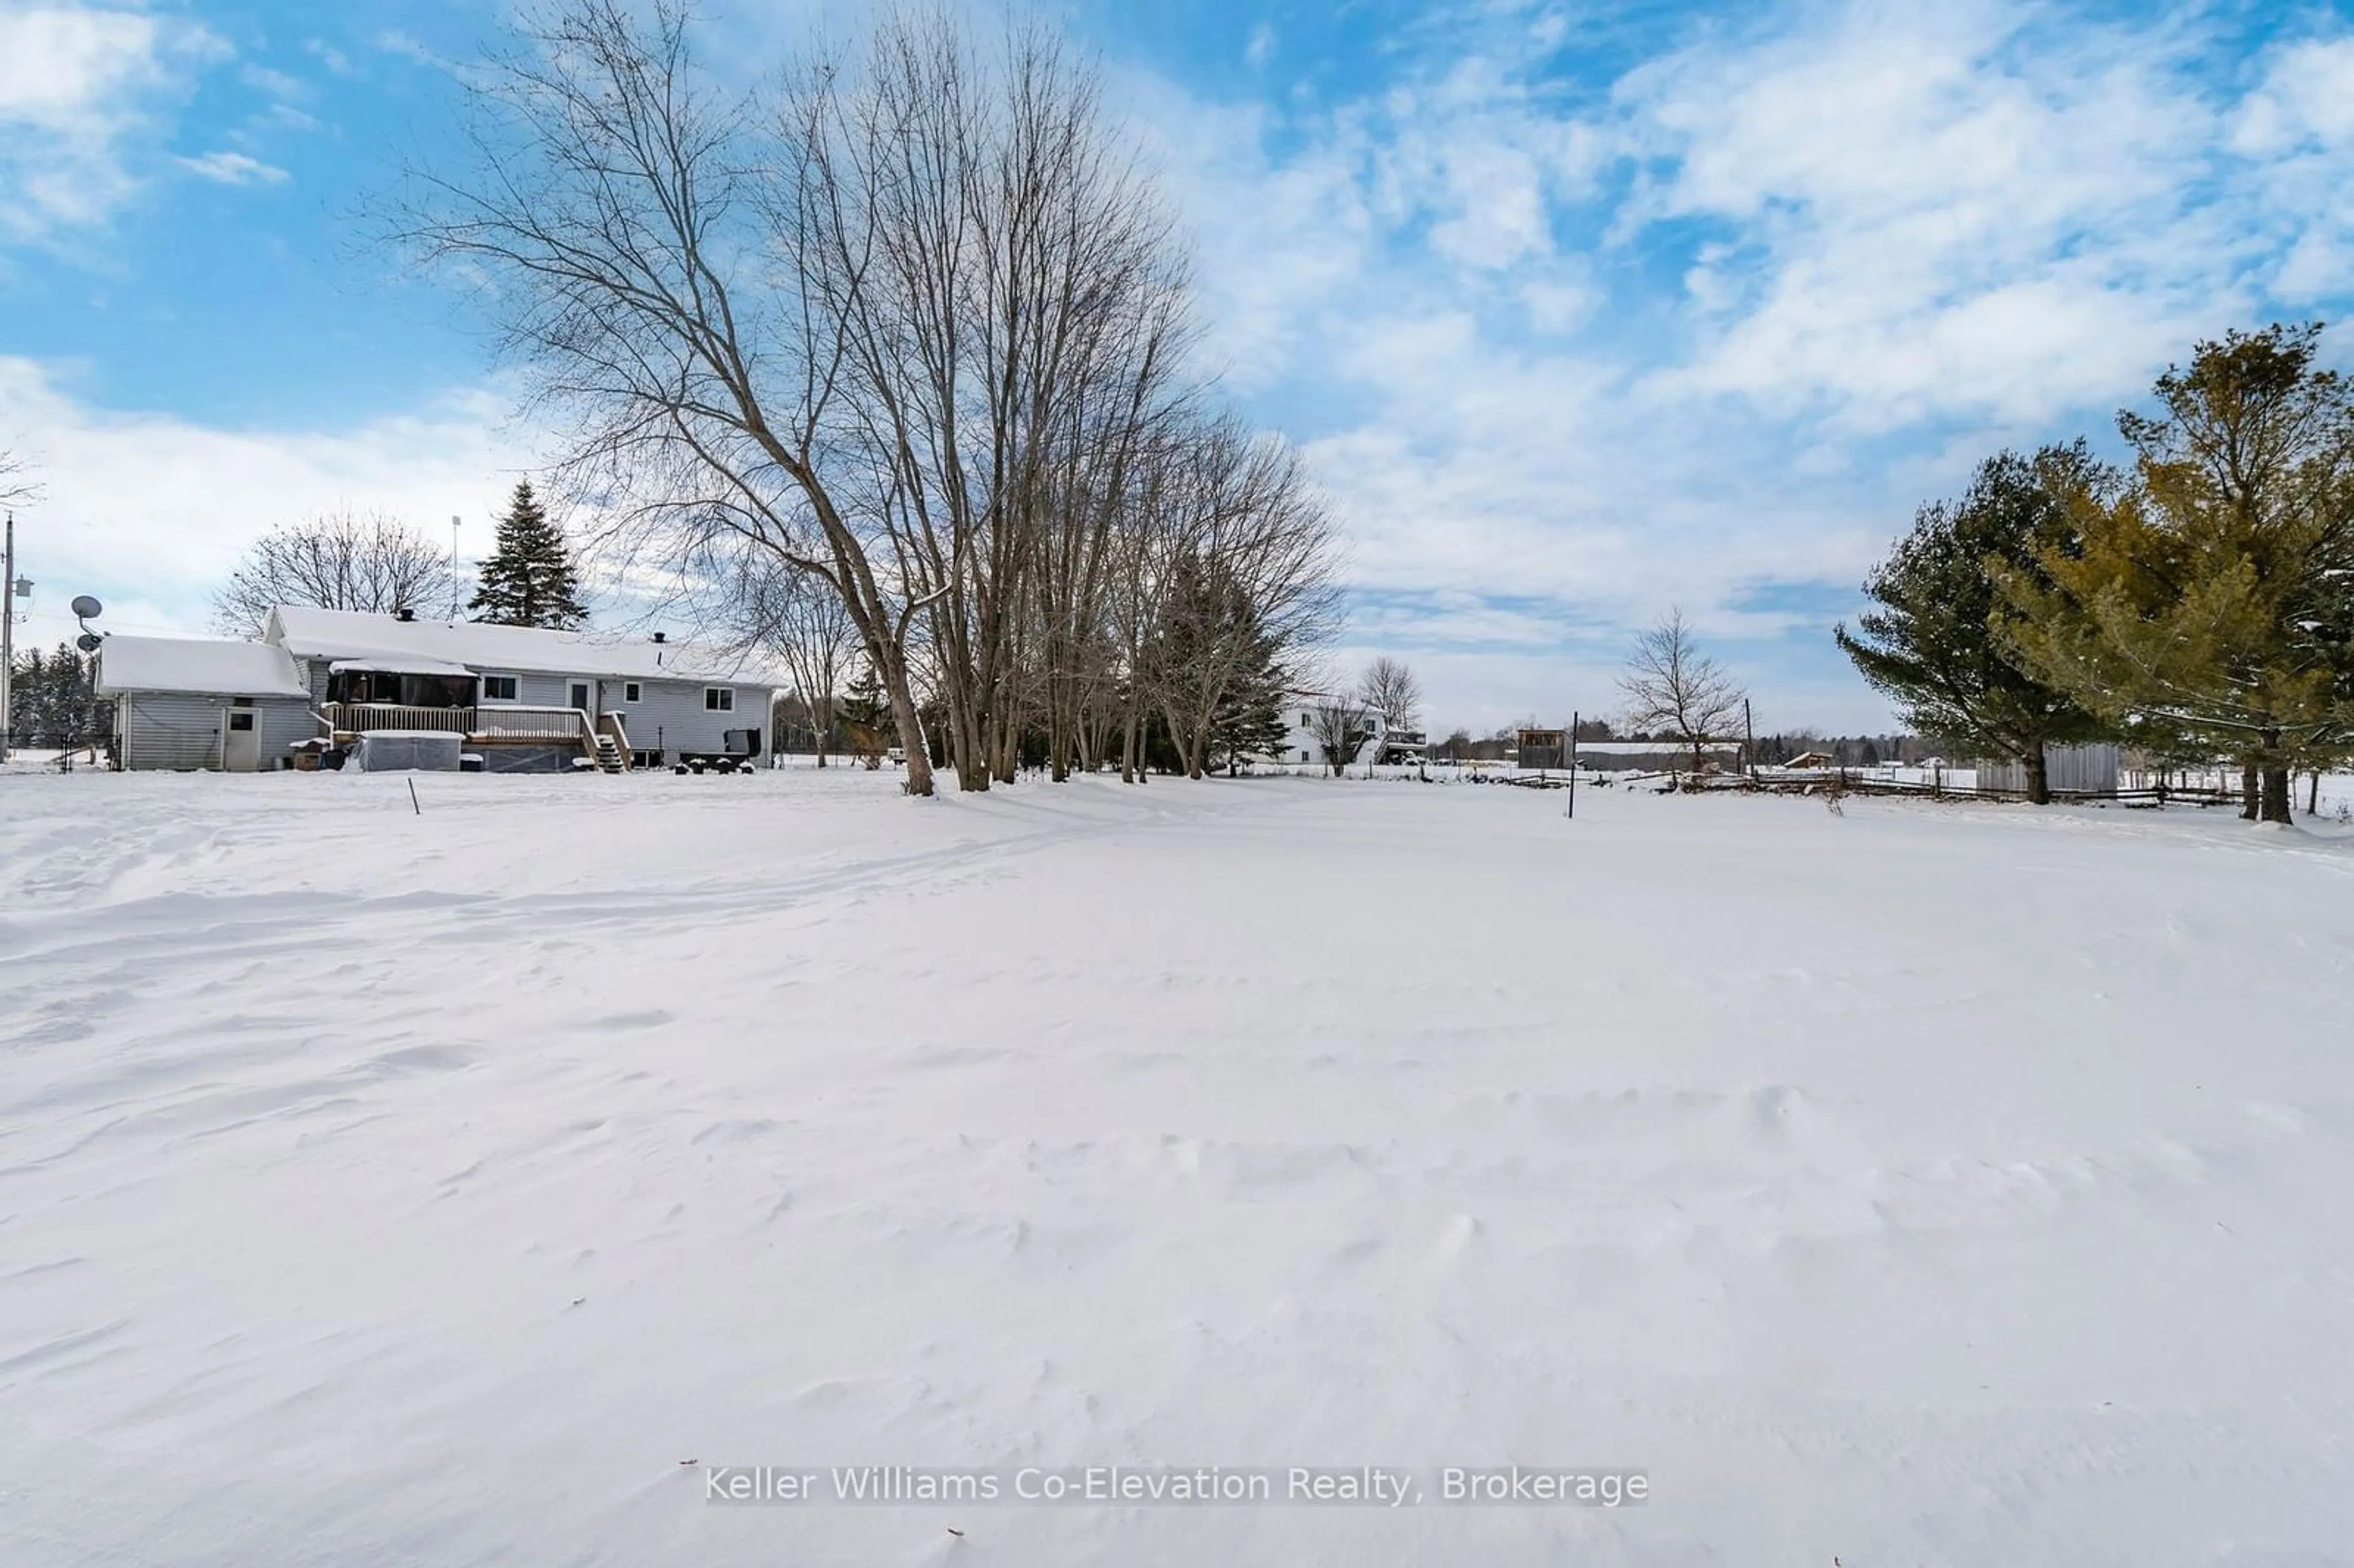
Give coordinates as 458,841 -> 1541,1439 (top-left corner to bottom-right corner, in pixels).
212,511 -> 454,636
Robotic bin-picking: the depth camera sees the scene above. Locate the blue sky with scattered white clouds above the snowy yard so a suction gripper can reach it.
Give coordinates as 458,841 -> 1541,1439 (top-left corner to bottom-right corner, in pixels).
0,0 -> 2354,728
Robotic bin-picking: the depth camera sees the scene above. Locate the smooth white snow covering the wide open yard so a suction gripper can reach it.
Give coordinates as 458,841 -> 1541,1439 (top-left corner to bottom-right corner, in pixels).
0,770 -> 2354,1568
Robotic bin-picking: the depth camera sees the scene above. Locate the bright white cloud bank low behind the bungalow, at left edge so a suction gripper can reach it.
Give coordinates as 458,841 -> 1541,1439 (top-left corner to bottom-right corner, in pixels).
0,356 -> 535,638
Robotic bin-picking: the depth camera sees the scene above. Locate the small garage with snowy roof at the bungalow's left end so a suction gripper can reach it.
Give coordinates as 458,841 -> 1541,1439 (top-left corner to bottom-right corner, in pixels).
96,636 -> 318,772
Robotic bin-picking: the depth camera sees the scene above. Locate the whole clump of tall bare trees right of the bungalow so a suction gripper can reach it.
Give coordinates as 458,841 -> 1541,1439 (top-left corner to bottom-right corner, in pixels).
393,0 -> 1330,793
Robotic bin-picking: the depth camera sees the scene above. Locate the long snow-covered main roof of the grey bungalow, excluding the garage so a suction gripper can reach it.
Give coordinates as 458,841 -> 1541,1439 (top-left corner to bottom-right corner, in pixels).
264,605 -> 772,685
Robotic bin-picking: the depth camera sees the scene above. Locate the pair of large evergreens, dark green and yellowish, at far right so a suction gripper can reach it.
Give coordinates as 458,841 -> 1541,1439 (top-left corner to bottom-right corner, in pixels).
1834,322 -> 2354,821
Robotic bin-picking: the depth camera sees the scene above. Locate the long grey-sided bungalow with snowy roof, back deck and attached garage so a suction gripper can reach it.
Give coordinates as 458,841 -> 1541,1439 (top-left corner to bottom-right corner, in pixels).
99,605 -> 772,772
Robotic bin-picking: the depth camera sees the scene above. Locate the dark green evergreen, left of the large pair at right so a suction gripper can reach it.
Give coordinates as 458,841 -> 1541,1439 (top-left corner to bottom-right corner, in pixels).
1832,440 -> 2116,805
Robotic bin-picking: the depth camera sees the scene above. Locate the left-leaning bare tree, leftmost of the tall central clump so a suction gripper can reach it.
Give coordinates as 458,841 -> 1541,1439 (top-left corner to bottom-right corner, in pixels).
393,0 -> 937,793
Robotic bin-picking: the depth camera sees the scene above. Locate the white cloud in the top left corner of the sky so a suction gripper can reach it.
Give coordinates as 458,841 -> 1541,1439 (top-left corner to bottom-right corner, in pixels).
0,0 -> 224,240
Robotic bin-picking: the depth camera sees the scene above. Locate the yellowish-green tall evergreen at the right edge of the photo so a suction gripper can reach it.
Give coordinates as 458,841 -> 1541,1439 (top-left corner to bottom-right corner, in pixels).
1996,325 -> 2354,821
